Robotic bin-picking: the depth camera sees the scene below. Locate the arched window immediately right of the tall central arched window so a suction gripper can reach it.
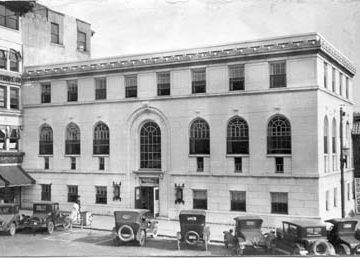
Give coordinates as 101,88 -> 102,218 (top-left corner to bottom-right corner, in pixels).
190,118 -> 210,154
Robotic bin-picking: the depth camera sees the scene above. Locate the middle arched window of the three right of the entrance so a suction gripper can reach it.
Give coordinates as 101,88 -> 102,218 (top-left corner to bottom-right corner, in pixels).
226,117 -> 249,154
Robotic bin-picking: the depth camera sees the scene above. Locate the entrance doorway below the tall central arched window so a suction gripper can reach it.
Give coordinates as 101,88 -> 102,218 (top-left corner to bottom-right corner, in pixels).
135,186 -> 160,217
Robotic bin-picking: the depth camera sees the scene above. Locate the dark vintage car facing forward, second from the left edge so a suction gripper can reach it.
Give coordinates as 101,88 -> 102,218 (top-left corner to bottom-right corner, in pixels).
23,201 -> 68,234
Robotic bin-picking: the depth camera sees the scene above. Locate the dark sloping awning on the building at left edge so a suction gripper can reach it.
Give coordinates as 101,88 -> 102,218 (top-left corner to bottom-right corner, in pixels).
0,166 -> 35,187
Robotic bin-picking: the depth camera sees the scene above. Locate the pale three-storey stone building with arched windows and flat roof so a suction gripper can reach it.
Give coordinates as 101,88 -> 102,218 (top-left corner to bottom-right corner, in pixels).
22,33 -> 355,225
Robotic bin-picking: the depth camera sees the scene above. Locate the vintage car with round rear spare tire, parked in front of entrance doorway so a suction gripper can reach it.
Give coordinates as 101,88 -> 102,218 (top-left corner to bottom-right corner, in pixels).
113,209 -> 158,246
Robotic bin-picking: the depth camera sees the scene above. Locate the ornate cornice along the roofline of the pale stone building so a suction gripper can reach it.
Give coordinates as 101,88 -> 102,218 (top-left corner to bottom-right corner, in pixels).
23,33 -> 356,80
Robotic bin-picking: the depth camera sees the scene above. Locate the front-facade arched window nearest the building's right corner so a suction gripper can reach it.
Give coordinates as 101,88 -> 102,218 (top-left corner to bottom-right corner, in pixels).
267,115 -> 291,154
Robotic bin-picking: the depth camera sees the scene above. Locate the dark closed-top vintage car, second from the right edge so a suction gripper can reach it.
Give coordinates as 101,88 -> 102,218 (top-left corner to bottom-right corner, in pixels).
273,220 -> 335,256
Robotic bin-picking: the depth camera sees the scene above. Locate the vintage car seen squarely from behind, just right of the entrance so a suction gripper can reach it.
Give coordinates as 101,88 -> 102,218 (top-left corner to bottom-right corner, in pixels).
176,210 -> 210,250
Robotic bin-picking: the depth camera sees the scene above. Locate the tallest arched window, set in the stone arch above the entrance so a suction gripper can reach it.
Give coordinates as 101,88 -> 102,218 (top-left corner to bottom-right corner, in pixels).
140,122 -> 161,169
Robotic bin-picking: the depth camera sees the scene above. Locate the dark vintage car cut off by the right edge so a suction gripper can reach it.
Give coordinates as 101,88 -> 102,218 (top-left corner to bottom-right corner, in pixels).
325,218 -> 360,255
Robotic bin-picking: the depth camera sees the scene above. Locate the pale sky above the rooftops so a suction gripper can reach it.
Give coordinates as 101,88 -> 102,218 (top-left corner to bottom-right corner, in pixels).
38,0 -> 360,109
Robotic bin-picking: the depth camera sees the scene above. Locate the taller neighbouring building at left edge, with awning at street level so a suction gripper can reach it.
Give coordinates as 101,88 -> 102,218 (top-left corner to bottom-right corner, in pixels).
0,1 -> 92,205
